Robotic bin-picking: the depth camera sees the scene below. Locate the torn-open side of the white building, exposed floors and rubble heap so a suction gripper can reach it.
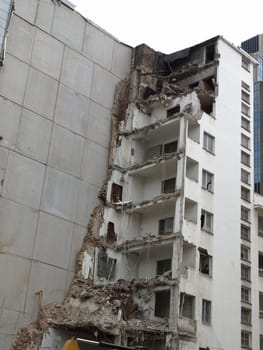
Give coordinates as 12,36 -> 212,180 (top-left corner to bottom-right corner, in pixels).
12,38 -> 218,350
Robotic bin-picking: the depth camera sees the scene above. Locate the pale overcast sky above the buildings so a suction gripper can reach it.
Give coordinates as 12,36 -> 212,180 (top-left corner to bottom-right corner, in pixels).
71,0 -> 263,53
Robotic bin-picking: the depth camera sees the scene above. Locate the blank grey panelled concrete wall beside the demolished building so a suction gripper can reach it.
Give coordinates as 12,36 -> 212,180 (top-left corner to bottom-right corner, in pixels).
0,0 -> 131,349
